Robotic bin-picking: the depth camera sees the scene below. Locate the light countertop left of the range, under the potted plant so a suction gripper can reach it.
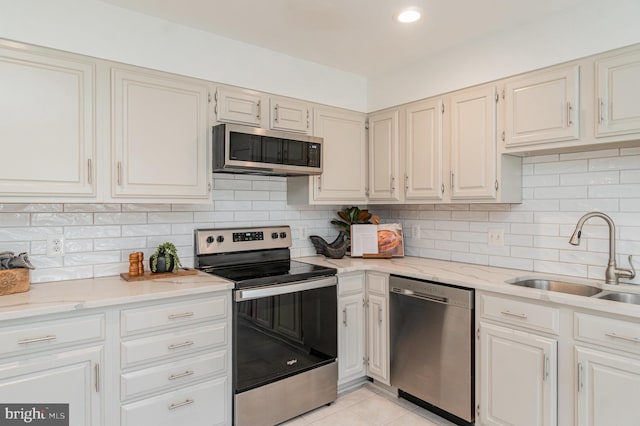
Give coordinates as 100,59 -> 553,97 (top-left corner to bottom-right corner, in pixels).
0,272 -> 233,321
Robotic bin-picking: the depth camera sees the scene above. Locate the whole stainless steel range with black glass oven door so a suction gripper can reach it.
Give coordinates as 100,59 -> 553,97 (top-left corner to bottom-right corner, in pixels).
194,226 -> 338,426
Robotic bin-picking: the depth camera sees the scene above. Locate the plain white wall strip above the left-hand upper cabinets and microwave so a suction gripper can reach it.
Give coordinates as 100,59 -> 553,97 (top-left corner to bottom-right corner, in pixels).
0,0 -> 366,111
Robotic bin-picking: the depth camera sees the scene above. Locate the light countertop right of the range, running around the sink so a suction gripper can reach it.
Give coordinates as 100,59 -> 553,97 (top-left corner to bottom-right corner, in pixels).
296,256 -> 640,319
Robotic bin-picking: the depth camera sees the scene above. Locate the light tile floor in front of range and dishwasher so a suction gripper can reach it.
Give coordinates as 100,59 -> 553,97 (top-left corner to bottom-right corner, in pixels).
281,384 -> 455,426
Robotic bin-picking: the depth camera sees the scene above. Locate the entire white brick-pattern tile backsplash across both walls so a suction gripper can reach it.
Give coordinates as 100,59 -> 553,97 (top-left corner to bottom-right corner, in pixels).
0,148 -> 640,284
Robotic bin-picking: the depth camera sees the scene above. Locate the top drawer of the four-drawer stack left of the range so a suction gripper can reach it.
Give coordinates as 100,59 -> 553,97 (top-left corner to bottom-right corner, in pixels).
120,296 -> 228,336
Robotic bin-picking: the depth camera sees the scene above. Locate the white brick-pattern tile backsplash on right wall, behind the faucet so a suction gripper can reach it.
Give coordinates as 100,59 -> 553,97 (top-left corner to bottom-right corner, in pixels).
376,148 -> 640,284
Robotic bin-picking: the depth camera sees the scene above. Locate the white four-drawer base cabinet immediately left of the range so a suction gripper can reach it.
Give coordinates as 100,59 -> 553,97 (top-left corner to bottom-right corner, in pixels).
120,294 -> 231,426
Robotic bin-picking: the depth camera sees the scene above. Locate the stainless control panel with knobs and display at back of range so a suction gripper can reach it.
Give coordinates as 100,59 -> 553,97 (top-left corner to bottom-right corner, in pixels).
194,226 -> 291,256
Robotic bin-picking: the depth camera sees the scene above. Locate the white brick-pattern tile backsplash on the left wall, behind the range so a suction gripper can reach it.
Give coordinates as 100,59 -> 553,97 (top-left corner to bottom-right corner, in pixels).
0,174 -> 342,283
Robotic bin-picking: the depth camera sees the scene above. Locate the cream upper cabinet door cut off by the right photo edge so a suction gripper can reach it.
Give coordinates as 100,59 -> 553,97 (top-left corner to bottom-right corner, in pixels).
596,51 -> 640,137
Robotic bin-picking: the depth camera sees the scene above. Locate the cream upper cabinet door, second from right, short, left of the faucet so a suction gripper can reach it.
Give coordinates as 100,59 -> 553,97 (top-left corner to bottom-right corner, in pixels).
504,65 -> 580,148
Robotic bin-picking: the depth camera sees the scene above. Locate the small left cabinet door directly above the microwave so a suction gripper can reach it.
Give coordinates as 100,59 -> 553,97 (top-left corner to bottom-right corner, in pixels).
215,88 -> 262,127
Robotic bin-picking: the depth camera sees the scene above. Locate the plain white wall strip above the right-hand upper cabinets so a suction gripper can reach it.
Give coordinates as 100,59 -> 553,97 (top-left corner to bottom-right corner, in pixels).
367,0 -> 640,111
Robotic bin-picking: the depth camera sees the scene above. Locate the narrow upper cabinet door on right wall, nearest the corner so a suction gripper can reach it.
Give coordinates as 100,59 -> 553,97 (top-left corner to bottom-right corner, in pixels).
369,110 -> 402,201
